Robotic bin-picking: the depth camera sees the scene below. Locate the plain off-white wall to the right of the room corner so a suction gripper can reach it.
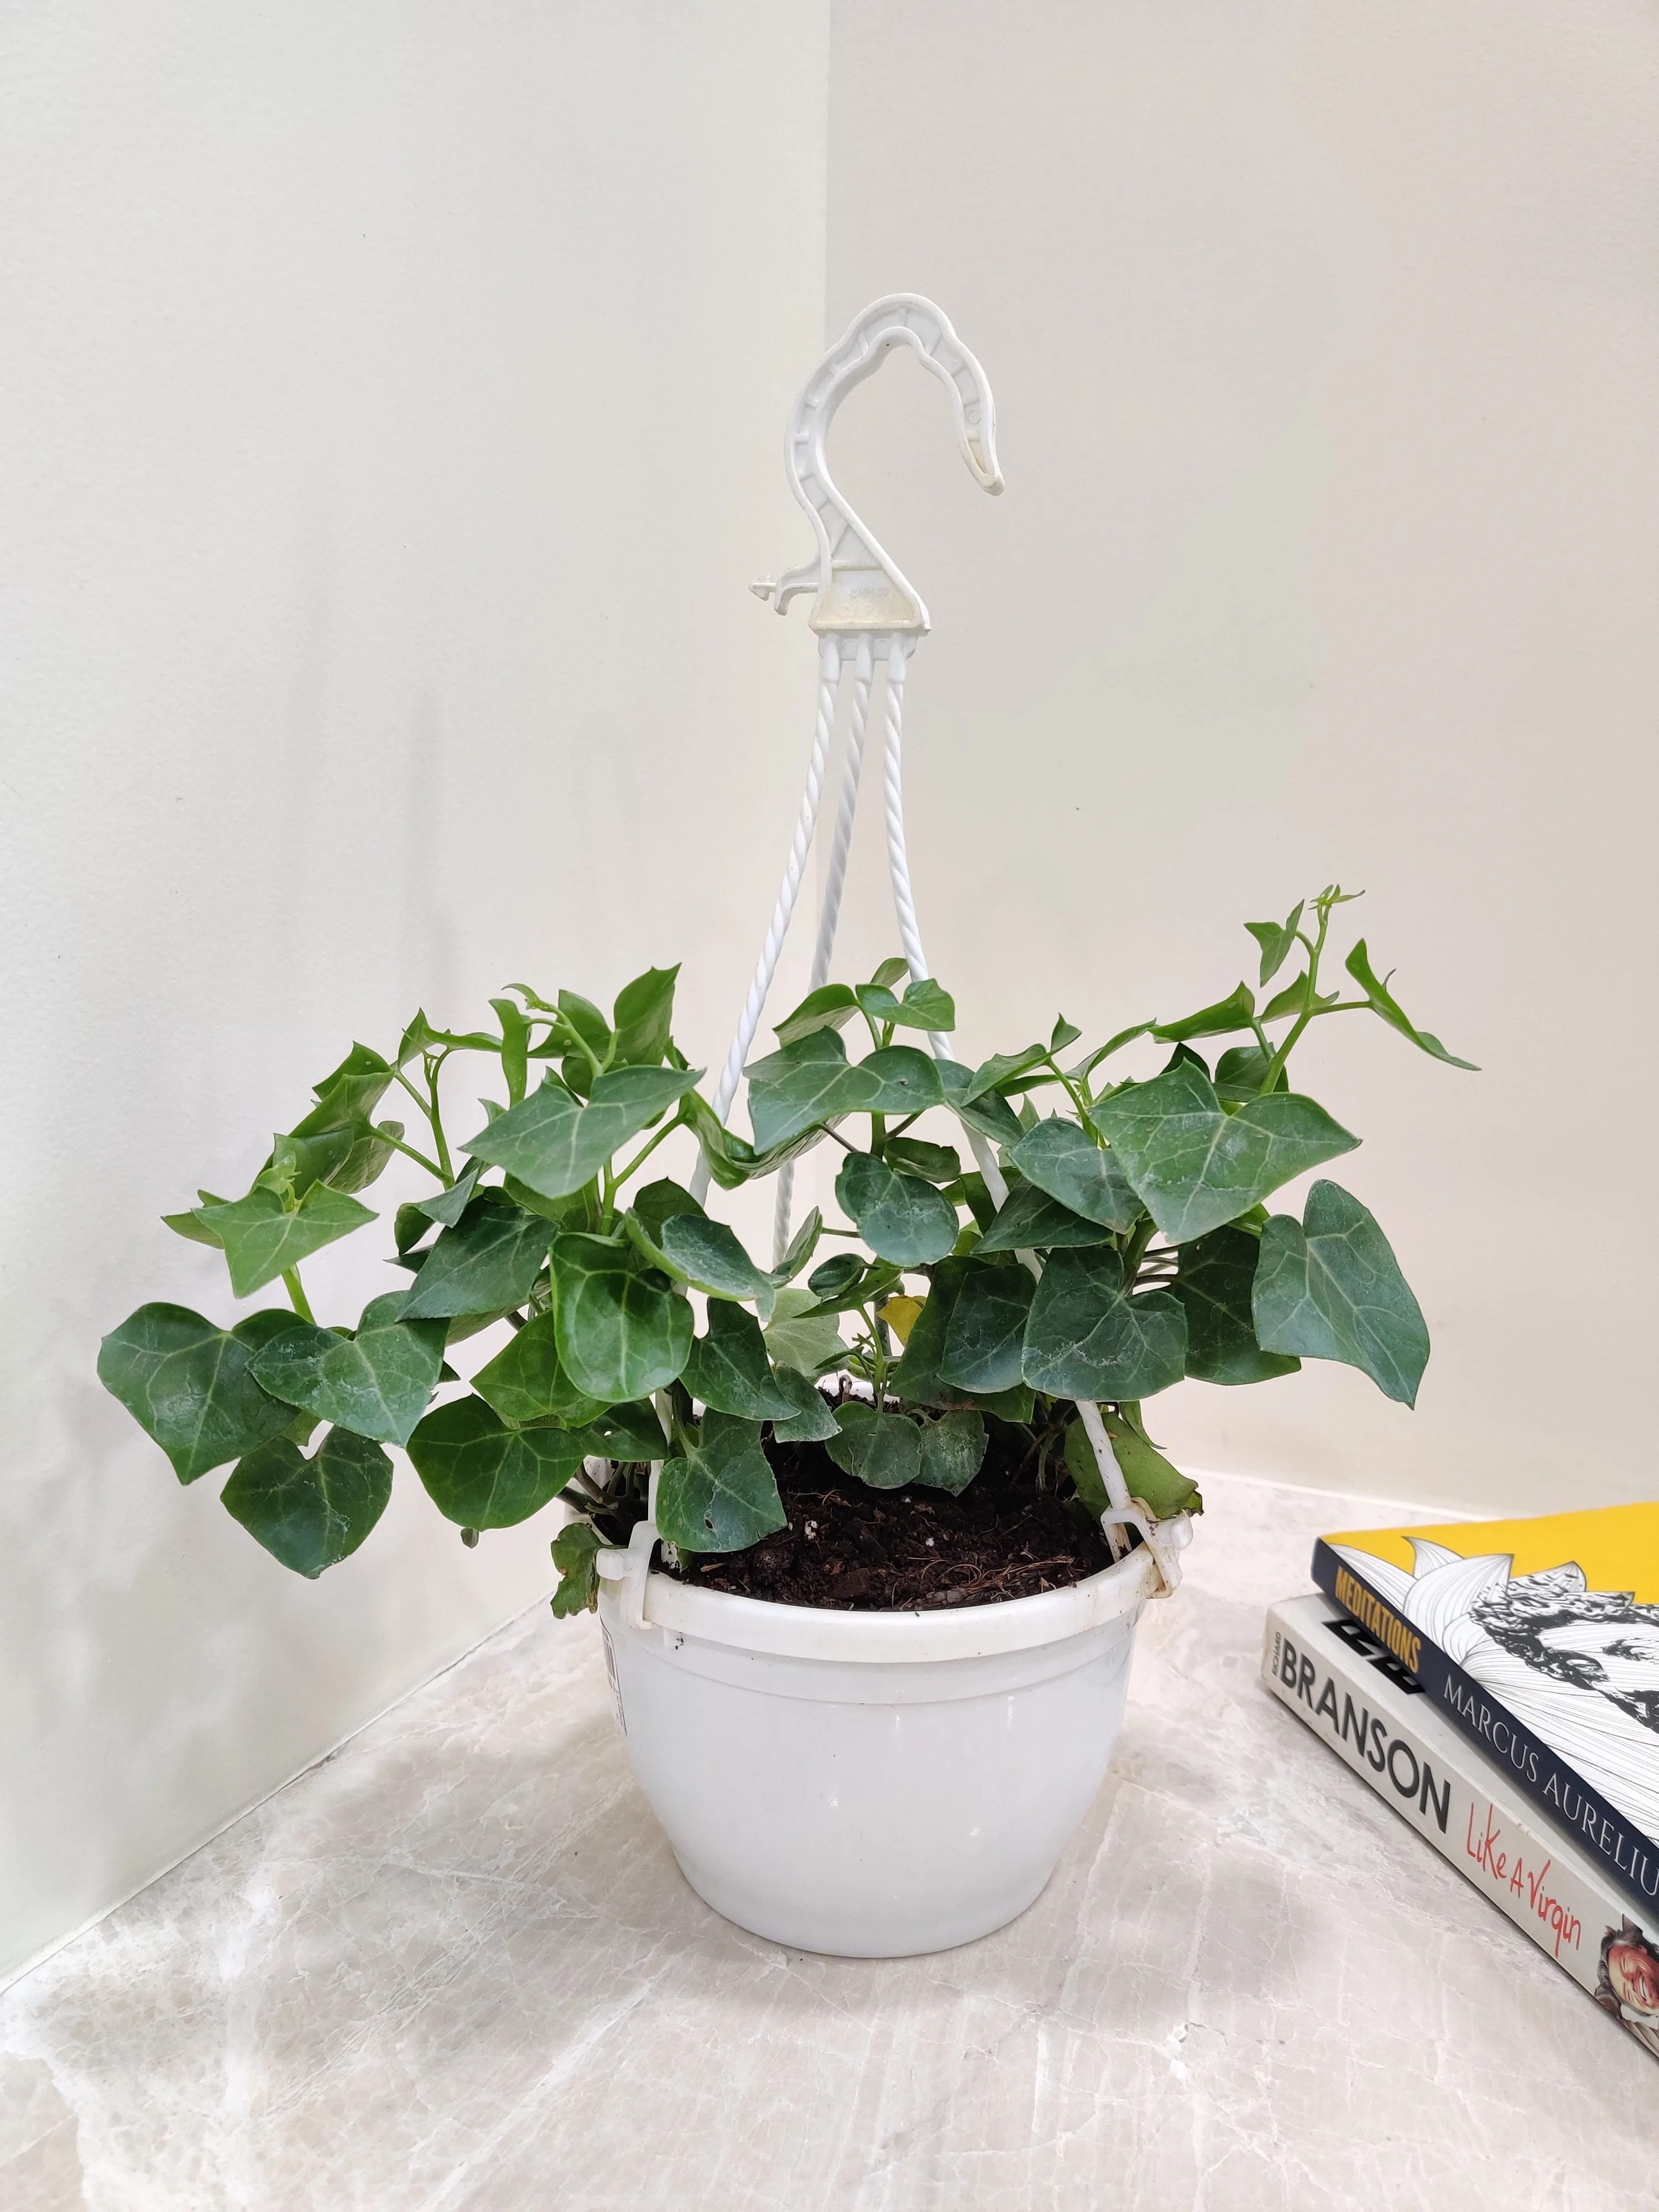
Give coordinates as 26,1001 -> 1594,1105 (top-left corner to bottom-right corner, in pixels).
830,0 -> 1659,1511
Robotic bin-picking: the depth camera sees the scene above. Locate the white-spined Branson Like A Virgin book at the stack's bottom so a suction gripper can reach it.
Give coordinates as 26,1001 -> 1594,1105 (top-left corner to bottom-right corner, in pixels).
1261,1597 -> 1659,2057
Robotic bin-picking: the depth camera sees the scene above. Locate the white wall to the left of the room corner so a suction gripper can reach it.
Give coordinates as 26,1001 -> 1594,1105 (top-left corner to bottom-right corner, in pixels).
0,0 -> 827,1971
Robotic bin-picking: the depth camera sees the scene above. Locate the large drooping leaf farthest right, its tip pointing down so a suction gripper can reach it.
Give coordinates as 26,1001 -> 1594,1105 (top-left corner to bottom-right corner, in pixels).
1252,1183 -> 1429,1405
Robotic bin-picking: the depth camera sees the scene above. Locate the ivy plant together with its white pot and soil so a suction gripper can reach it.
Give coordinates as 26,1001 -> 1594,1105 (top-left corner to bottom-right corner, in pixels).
97,887 -> 1467,1955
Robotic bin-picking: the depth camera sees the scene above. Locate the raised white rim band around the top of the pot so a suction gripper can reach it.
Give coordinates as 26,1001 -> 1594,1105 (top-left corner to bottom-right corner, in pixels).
599,1544 -> 1161,1666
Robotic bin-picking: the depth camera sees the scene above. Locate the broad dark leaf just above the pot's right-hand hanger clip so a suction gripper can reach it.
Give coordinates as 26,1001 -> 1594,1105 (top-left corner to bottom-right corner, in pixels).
1024,1252 -> 1186,1400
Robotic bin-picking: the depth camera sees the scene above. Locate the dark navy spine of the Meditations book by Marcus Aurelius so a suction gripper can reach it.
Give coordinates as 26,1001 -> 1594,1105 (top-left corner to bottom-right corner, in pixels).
1314,1537 -> 1659,1916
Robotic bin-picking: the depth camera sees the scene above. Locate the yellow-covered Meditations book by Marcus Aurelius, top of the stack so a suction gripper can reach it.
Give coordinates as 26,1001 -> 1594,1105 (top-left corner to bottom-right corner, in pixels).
1314,1504 -> 1659,1918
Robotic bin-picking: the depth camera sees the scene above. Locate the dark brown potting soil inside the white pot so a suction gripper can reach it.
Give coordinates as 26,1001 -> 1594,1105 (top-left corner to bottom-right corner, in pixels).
670,1433 -> 1113,1613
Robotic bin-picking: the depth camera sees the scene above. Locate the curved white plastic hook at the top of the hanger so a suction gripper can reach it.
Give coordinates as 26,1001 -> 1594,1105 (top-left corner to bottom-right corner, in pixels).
750,292 -> 1002,637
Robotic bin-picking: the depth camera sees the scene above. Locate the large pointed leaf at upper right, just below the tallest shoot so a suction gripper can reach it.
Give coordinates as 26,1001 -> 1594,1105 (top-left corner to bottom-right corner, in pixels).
1091,1064 -> 1358,1243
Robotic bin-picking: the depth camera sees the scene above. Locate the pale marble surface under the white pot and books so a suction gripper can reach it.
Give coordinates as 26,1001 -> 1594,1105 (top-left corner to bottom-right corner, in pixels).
0,1480 -> 1659,2212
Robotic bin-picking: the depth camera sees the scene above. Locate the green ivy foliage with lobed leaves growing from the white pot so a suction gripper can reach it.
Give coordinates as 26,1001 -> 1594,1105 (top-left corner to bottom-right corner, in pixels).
97,885 -> 1469,1613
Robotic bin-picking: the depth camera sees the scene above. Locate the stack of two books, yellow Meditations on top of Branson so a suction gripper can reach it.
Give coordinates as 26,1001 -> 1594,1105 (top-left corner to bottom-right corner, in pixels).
1261,1504 -> 1659,2057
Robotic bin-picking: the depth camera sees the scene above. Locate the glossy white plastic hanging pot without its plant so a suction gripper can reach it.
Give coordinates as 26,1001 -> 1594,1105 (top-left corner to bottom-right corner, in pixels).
599,1546 -> 1159,1958
